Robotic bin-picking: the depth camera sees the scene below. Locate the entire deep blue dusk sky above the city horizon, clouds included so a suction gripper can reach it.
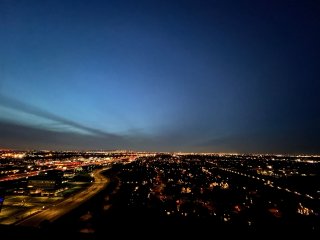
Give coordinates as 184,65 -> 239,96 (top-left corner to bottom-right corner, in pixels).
0,0 -> 320,153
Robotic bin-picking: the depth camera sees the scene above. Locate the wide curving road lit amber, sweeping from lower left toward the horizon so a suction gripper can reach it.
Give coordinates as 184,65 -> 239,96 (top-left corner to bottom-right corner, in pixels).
15,169 -> 109,227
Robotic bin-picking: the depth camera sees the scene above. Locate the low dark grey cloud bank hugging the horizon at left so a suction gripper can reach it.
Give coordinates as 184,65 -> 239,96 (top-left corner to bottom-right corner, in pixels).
0,120 -> 129,150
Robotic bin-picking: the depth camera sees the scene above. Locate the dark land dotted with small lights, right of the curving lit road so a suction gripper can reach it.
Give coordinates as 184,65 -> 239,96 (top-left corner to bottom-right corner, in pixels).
0,155 -> 320,239
